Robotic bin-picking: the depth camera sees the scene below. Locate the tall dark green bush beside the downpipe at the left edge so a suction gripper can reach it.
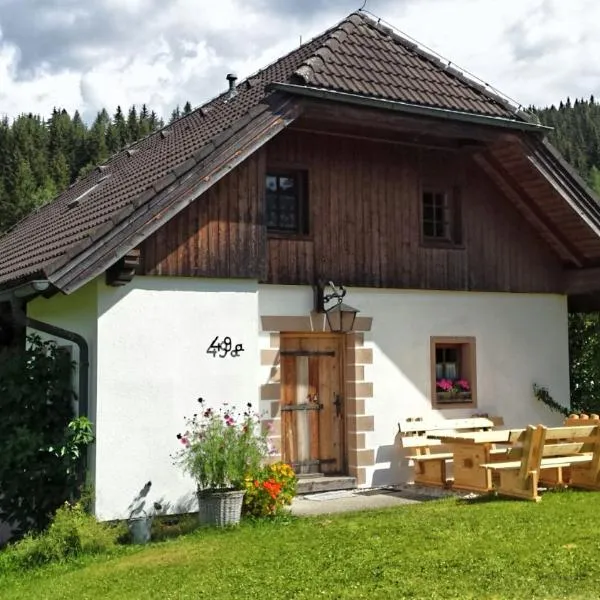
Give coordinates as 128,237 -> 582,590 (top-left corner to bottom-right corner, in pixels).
0,336 -> 93,538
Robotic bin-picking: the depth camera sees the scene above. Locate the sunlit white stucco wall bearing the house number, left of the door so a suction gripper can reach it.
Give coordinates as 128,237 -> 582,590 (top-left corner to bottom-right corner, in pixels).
95,277 -> 260,519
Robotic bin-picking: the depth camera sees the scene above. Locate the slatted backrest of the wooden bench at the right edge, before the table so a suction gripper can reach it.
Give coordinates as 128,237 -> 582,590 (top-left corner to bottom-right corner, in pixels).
507,425 -> 600,476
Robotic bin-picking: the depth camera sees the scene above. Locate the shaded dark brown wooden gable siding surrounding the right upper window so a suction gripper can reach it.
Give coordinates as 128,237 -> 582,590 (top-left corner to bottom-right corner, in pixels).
267,130 -> 562,292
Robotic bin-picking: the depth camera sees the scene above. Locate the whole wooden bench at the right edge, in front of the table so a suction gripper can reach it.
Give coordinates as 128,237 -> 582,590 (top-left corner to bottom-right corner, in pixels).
482,425 -> 600,502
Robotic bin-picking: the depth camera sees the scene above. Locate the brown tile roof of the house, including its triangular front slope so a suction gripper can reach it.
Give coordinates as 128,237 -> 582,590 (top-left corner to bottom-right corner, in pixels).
0,13 -> 536,290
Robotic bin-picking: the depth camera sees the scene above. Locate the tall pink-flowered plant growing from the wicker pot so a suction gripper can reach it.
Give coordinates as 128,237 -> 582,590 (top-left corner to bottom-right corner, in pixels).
174,398 -> 268,490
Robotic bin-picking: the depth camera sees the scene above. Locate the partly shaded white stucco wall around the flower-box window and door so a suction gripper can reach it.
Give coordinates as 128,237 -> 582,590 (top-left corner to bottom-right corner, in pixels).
259,285 -> 569,485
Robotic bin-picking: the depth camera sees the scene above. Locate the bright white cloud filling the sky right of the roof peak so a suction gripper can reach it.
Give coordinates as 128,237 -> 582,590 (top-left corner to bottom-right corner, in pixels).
386,0 -> 600,106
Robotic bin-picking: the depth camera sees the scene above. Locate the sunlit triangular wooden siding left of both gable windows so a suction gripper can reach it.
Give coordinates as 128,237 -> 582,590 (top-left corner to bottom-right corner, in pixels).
141,150 -> 266,279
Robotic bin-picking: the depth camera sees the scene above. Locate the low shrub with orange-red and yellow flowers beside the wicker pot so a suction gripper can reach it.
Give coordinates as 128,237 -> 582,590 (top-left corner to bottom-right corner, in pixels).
244,462 -> 296,517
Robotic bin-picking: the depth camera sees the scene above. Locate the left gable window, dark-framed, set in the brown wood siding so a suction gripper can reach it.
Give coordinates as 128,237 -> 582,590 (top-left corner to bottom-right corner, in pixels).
265,171 -> 308,235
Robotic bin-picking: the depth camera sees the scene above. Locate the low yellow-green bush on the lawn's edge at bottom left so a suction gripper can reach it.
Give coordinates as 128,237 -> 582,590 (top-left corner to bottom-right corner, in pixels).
5,502 -> 122,569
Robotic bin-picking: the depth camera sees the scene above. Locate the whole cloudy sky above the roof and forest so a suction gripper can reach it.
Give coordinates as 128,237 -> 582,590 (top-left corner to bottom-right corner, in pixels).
0,0 -> 600,118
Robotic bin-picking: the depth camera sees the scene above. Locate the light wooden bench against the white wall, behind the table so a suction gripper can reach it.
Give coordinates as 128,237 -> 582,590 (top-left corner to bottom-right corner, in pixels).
398,417 -> 501,487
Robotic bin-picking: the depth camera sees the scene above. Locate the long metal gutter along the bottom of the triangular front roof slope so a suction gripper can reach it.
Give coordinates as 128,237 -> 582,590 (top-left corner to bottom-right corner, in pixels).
269,83 -> 553,134
